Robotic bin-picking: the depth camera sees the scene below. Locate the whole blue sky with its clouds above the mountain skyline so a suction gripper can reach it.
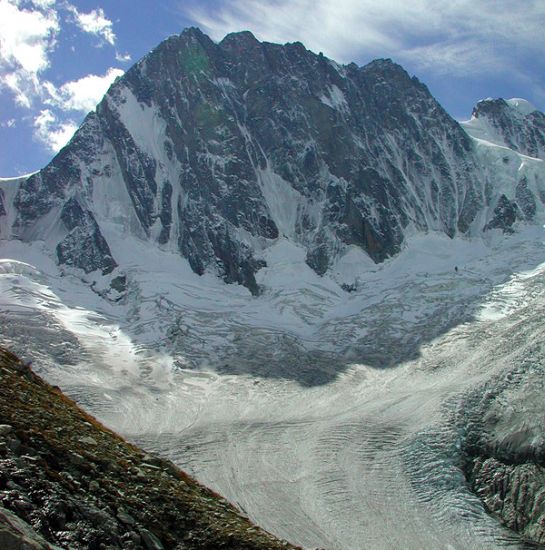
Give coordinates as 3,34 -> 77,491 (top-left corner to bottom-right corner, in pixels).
0,0 -> 545,177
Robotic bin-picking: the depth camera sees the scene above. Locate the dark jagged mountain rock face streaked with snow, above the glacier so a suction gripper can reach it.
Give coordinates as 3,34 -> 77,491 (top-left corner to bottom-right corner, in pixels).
0,28 -> 543,293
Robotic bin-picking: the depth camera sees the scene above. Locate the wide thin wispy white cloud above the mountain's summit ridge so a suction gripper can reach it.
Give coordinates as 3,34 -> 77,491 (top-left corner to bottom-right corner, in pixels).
189,0 -> 545,74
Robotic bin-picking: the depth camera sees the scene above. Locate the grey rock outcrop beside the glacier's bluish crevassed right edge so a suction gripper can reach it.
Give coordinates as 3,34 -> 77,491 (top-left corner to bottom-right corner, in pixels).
463,362 -> 545,548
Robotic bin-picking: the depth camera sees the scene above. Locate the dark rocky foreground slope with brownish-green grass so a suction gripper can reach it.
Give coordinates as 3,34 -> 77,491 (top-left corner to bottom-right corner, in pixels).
0,348 -> 294,550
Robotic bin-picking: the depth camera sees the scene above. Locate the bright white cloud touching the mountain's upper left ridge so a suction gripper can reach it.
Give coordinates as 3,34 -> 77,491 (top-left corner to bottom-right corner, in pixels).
45,67 -> 124,113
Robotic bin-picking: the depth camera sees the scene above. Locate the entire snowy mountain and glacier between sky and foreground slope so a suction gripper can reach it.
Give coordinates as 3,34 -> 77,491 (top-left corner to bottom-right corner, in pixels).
0,28 -> 545,550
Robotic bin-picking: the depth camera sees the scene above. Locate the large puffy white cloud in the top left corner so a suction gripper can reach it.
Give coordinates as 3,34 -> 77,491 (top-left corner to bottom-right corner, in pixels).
0,0 -> 60,107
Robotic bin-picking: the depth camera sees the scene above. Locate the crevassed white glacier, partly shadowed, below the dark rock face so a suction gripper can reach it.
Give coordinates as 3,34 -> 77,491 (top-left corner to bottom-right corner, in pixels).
0,223 -> 545,550
